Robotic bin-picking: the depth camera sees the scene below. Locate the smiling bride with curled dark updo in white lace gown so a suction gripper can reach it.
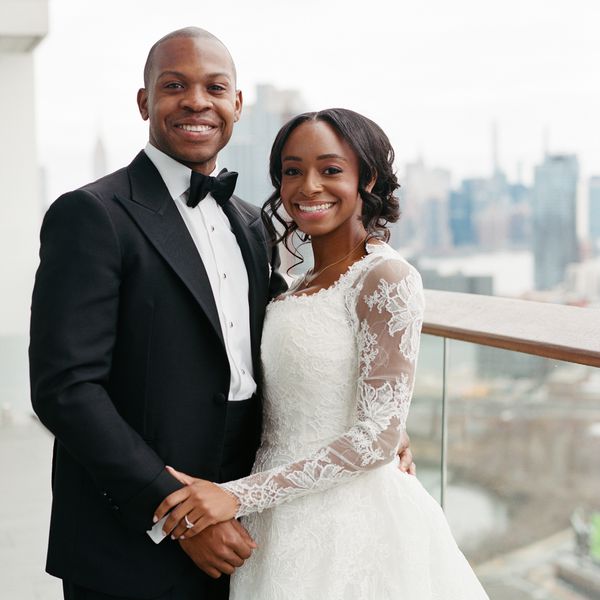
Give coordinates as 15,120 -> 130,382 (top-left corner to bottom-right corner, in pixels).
157,109 -> 487,600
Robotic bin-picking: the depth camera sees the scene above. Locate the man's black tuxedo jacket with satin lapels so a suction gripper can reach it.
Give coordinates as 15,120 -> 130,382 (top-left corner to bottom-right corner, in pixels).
30,152 -> 284,597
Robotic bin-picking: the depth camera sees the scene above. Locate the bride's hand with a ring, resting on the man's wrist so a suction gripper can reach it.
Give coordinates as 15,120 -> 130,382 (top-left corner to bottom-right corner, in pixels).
154,467 -> 239,539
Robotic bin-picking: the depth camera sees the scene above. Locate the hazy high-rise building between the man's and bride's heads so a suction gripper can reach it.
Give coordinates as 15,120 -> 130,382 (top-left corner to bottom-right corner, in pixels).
219,85 -> 305,206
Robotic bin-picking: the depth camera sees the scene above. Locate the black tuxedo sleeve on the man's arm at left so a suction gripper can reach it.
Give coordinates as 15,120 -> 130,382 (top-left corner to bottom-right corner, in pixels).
29,190 -> 181,531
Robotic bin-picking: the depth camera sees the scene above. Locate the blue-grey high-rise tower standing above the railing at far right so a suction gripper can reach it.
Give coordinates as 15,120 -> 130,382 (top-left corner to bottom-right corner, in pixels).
533,154 -> 579,290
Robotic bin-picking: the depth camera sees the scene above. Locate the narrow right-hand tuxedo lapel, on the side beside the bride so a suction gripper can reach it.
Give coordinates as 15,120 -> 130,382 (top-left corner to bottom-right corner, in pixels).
223,196 -> 268,365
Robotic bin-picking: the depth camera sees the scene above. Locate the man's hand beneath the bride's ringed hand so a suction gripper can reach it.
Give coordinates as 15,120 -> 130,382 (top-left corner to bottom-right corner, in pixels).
179,519 -> 257,579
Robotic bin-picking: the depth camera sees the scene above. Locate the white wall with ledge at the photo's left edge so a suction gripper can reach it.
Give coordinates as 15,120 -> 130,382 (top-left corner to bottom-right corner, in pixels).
0,0 -> 48,338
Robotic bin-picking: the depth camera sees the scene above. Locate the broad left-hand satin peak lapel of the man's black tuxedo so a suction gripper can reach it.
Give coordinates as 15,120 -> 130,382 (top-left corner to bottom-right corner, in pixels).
116,152 -> 224,343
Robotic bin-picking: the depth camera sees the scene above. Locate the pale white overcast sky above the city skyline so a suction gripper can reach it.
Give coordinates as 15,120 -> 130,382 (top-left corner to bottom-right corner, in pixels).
36,0 -> 600,204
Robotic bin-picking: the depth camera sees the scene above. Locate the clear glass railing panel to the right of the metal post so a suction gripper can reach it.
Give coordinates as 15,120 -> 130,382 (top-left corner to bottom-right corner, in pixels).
445,340 -> 600,600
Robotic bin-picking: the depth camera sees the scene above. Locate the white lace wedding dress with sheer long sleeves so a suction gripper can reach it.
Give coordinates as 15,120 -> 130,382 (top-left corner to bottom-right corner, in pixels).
223,243 -> 487,600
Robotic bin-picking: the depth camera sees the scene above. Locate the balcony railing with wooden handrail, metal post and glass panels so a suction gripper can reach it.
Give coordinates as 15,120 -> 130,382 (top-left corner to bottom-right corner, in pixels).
418,290 -> 600,599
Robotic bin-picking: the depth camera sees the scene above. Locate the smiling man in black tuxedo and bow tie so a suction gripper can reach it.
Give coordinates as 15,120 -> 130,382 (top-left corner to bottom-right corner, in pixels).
30,28 -> 412,600
